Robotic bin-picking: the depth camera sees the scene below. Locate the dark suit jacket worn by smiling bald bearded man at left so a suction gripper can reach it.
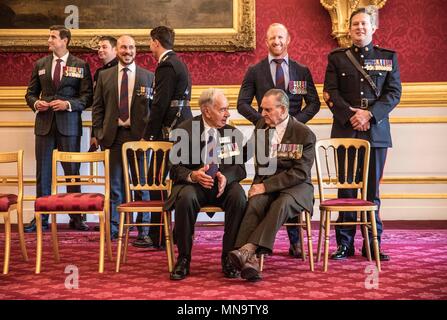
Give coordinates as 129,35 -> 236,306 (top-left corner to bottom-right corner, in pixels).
92,65 -> 154,148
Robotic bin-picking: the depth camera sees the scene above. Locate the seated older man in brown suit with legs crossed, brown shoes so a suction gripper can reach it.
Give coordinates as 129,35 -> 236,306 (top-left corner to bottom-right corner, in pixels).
229,89 -> 316,281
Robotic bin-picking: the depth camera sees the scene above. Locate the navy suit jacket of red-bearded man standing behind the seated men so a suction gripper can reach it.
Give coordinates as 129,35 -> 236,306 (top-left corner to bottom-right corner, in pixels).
237,58 -> 320,124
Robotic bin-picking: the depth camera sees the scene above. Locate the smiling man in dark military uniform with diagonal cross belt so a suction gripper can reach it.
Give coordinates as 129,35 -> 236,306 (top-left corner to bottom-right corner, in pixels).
324,8 -> 402,261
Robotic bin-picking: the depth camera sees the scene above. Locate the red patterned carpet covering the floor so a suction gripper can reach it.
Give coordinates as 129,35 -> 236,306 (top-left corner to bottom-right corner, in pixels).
0,227 -> 447,300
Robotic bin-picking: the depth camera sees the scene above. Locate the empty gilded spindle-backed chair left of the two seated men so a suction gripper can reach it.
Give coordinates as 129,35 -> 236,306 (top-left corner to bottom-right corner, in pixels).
116,141 -> 175,272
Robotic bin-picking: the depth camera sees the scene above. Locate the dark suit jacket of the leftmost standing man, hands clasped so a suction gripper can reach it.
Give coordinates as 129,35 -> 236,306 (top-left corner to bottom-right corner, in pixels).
25,54 -> 93,136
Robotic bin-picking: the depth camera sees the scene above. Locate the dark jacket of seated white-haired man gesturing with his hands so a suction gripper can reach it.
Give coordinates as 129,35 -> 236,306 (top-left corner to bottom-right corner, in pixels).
165,115 -> 247,210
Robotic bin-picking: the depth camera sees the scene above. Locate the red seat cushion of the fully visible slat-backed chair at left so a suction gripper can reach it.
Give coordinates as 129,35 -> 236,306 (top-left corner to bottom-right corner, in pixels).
34,193 -> 104,211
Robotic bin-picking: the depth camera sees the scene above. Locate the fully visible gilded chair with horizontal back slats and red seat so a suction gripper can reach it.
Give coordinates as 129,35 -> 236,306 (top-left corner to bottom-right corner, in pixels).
34,150 -> 113,273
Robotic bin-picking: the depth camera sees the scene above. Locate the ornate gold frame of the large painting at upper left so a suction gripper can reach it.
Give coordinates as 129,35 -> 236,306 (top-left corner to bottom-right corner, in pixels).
0,0 -> 256,52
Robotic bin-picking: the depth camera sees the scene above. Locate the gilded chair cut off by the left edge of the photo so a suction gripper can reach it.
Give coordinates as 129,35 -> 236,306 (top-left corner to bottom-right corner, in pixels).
0,150 -> 28,274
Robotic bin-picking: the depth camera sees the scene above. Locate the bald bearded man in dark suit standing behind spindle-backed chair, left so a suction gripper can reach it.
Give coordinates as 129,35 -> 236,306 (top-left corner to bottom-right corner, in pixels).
92,35 -> 154,240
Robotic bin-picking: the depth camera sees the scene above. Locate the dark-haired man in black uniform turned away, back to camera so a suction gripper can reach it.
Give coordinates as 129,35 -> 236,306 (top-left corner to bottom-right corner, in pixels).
143,26 -> 192,246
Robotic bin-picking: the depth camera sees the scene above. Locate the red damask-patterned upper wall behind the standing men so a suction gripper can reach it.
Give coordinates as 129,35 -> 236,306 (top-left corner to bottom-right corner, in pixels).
0,0 -> 447,86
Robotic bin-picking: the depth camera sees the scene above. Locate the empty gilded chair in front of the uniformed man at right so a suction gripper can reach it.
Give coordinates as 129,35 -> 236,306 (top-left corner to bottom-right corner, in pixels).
315,138 -> 380,272
